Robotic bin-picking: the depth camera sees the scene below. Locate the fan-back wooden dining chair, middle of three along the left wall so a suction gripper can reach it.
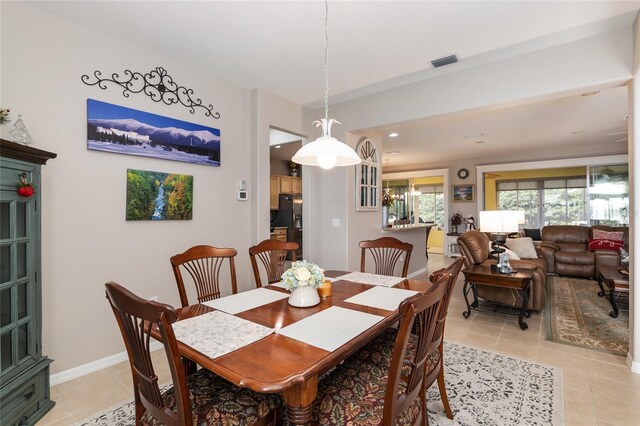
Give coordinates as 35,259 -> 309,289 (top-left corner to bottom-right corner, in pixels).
171,245 -> 238,307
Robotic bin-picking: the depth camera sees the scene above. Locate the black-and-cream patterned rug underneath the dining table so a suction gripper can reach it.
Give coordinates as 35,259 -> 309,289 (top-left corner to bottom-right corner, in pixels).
76,342 -> 564,426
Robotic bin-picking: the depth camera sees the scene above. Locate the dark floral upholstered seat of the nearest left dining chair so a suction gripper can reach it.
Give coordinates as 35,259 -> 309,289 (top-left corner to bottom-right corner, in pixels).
142,369 -> 282,426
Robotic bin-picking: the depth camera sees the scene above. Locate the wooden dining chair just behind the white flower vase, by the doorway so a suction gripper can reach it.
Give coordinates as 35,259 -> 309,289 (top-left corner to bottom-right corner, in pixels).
249,240 -> 300,288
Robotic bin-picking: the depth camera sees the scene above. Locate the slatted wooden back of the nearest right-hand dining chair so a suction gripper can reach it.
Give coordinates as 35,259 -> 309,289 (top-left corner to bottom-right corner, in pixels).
382,273 -> 451,425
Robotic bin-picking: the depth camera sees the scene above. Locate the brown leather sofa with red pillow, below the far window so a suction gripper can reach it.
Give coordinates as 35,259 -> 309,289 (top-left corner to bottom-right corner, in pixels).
539,225 -> 629,278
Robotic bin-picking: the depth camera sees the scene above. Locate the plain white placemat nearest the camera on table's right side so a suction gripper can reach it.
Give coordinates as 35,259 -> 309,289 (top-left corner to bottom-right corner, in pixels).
277,306 -> 384,351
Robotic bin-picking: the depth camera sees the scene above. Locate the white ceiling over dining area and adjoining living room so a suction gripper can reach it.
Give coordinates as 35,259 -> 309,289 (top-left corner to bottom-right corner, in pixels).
30,1 -> 640,165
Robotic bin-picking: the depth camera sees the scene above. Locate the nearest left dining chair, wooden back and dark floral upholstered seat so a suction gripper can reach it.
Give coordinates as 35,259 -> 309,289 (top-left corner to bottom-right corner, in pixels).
105,282 -> 282,426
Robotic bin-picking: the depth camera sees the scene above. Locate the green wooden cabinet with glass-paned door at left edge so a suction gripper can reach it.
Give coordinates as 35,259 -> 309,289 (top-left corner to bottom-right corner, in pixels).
0,139 -> 56,426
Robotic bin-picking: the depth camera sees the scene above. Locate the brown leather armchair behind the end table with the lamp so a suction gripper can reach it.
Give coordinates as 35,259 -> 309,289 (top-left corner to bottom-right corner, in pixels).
458,231 -> 547,312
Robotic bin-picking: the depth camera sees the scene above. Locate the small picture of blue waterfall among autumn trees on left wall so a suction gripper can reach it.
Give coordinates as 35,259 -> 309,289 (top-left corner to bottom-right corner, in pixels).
126,169 -> 193,220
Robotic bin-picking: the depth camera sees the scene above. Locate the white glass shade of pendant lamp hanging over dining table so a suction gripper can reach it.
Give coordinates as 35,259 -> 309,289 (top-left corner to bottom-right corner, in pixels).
291,136 -> 361,169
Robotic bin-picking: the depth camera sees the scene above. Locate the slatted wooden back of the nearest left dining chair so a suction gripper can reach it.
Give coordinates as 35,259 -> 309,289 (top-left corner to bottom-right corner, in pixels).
105,282 -> 192,426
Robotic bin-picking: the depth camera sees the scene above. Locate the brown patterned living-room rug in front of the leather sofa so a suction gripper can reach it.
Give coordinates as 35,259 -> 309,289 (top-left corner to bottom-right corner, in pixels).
545,276 -> 629,356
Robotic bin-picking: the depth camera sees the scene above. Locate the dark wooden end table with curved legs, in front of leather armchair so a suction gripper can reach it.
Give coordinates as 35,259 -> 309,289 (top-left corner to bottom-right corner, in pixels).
462,265 -> 533,330
